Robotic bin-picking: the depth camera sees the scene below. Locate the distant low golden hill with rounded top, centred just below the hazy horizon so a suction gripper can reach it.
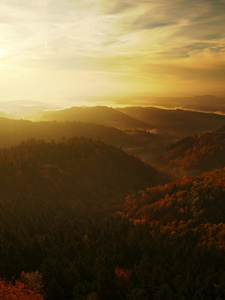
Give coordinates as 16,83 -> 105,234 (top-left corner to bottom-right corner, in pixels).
35,106 -> 152,129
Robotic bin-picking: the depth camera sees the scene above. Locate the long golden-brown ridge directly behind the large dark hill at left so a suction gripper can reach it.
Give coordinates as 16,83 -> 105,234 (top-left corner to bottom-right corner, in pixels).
0,117 -> 136,148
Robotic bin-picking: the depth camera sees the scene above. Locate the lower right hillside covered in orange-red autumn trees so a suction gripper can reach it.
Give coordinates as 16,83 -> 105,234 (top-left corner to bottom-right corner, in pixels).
123,168 -> 225,226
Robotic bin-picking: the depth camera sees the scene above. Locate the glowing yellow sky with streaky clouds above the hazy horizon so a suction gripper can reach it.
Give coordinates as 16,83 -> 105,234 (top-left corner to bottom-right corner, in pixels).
0,0 -> 225,106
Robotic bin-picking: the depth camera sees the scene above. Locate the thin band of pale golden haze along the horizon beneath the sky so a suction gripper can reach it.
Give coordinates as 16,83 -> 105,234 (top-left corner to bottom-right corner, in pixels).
0,95 -> 225,121
